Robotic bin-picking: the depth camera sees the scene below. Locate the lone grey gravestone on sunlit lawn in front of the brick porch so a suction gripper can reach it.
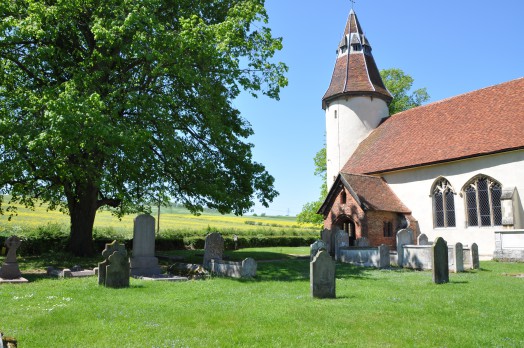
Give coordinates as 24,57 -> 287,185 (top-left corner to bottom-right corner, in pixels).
309,250 -> 336,298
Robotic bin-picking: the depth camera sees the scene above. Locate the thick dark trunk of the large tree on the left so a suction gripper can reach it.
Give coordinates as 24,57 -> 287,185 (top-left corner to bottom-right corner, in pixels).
66,184 -> 98,256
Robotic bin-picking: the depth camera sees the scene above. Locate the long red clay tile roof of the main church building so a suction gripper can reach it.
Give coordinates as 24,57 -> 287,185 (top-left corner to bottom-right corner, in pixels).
341,78 -> 524,174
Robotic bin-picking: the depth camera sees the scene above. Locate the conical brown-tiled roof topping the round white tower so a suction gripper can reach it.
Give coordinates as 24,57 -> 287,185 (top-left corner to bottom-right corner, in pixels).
322,9 -> 393,109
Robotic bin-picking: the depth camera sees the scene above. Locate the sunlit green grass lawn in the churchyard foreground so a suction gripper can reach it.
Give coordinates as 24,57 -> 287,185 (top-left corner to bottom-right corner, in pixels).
0,248 -> 524,347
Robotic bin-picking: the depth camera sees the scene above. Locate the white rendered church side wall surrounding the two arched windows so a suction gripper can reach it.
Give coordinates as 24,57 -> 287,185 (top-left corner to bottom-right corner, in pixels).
383,150 -> 524,257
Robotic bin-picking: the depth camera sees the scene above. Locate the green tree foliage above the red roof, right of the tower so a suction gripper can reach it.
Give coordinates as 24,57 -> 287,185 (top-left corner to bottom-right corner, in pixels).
380,69 -> 429,115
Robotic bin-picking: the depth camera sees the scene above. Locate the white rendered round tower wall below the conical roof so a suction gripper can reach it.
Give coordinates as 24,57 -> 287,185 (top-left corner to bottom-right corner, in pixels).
326,96 -> 389,189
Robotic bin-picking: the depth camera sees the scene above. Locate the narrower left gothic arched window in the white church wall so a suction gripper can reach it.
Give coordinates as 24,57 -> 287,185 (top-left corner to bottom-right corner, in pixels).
433,178 -> 456,227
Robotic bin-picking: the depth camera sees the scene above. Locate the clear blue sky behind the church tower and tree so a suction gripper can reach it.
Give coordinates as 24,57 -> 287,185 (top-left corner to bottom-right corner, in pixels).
234,0 -> 524,215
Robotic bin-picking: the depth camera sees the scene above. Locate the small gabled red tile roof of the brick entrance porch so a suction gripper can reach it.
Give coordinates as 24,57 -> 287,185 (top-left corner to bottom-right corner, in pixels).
318,173 -> 411,214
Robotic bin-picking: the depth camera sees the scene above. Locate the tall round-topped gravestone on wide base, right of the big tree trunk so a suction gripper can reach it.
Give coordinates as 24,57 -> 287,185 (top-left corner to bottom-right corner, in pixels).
130,214 -> 162,277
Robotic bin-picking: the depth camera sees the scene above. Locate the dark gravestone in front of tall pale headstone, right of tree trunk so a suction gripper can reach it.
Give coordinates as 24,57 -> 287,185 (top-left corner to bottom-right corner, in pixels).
98,240 -> 129,288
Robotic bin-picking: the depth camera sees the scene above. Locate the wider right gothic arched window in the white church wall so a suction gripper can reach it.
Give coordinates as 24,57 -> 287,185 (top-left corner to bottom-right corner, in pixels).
463,176 -> 502,227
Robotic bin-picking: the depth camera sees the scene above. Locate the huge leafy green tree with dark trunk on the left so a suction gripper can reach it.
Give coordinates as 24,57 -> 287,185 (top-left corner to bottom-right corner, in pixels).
0,0 -> 287,255
